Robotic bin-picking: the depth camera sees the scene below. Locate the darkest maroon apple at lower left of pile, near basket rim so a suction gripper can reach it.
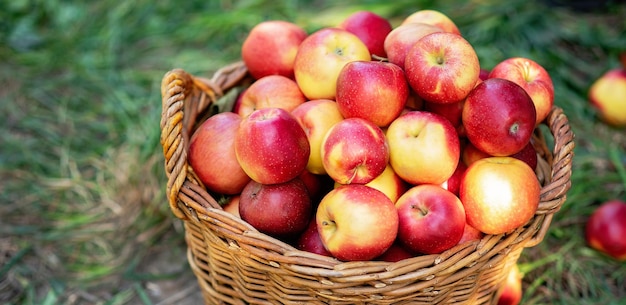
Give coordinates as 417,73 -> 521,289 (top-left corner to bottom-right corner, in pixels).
239,178 -> 313,238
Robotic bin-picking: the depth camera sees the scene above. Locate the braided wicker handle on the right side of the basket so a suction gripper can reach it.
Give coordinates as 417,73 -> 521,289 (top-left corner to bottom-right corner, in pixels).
525,106 -> 575,247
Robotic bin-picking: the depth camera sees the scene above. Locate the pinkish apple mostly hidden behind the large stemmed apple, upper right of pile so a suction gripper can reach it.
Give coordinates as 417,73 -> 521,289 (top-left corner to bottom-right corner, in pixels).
384,22 -> 443,69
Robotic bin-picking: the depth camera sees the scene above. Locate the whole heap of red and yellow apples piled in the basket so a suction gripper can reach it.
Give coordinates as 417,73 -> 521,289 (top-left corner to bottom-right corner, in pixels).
189,10 -> 554,261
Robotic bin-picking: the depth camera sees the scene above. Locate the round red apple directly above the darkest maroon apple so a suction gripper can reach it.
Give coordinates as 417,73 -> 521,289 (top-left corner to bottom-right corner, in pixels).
235,108 -> 311,184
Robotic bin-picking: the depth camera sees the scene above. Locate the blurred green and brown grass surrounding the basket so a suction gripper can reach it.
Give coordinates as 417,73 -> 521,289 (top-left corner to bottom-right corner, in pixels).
0,0 -> 626,305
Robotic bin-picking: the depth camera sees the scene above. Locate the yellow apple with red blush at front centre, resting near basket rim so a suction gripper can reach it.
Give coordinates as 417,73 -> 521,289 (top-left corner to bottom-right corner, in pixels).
316,184 -> 398,261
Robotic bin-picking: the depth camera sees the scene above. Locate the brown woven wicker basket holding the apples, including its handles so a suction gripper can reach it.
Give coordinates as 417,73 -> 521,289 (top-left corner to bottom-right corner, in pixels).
161,62 -> 574,304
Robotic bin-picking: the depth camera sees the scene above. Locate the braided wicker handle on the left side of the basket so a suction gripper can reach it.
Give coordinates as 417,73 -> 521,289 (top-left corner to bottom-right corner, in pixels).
160,62 -> 247,220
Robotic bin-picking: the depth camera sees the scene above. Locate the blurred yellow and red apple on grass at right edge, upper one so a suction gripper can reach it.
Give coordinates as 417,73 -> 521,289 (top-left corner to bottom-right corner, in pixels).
588,68 -> 626,127
